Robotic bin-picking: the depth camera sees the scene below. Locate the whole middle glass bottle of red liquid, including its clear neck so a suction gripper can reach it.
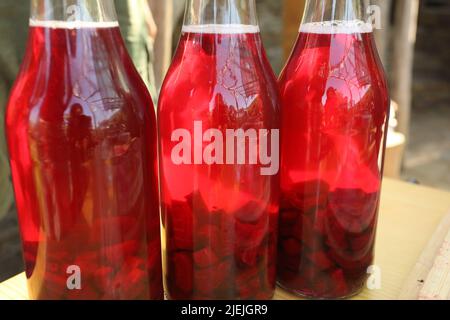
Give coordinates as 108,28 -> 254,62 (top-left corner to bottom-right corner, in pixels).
158,0 -> 280,299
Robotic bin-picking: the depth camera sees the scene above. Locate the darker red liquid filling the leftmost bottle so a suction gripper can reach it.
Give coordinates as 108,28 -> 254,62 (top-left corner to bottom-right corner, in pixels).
7,23 -> 163,300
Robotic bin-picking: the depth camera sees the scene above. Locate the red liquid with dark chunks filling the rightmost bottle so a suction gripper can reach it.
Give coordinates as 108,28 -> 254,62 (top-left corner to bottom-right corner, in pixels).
278,25 -> 389,298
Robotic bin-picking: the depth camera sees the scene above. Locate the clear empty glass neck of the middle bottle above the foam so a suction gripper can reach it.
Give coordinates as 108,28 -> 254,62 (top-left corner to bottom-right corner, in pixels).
184,0 -> 258,26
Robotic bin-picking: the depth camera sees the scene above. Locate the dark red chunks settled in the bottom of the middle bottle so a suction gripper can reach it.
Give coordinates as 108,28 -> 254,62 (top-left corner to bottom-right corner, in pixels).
165,192 -> 278,300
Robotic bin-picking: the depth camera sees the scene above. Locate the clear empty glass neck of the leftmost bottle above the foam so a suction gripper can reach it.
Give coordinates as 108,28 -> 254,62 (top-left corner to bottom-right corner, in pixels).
30,0 -> 118,22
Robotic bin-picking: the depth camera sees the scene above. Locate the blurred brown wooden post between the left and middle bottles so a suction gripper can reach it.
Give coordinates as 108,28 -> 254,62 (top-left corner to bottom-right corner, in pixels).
149,0 -> 173,91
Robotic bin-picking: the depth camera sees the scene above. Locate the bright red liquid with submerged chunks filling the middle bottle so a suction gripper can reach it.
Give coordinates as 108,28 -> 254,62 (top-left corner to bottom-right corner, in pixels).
158,26 -> 280,299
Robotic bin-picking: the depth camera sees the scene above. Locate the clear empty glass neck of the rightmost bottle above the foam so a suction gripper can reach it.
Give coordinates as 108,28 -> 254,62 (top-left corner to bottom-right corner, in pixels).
302,0 -> 369,24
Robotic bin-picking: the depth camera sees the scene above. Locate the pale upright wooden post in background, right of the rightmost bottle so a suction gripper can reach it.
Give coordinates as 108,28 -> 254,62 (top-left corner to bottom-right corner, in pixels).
391,0 -> 419,141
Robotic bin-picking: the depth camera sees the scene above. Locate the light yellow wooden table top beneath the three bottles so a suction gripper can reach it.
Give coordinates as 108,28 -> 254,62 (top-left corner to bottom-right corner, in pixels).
0,179 -> 450,300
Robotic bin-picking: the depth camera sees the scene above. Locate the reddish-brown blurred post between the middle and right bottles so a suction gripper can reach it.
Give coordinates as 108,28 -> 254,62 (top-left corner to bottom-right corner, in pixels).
283,0 -> 306,60
